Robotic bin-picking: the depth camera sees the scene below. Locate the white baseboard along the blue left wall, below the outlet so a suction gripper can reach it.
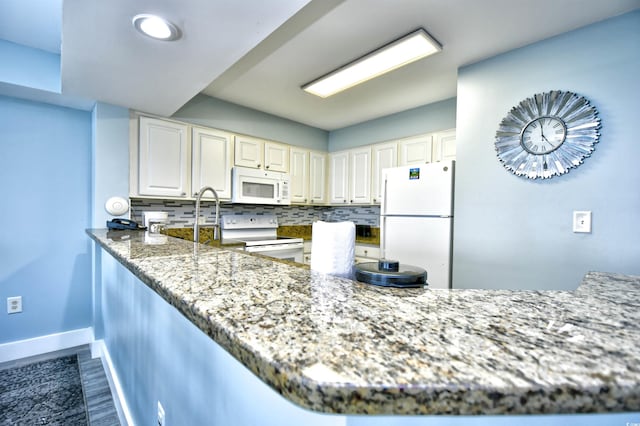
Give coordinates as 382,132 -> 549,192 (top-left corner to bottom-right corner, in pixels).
0,327 -> 94,363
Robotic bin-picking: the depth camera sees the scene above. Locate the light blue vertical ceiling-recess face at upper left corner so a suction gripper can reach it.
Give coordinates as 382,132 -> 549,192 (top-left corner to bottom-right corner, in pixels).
0,40 -> 60,93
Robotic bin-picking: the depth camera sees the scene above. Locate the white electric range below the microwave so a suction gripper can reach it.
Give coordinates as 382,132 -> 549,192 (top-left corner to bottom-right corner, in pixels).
220,214 -> 304,263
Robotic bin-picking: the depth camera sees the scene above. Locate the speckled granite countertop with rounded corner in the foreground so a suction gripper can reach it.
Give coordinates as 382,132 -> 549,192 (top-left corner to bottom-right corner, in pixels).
87,230 -> 640,414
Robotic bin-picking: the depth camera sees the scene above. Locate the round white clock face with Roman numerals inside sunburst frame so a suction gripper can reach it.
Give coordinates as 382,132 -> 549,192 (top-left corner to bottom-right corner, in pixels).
520,117 -> 567,155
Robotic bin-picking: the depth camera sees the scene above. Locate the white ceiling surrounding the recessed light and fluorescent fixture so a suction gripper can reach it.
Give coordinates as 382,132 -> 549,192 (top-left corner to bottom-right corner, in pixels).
0,0 -> 640,130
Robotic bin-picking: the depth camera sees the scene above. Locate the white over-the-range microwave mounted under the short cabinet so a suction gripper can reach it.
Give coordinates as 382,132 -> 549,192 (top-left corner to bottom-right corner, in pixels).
231,167 -> 291,205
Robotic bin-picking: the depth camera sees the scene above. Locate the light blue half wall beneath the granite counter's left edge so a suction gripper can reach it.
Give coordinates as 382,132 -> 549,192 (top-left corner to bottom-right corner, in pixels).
96,248 -> 345,426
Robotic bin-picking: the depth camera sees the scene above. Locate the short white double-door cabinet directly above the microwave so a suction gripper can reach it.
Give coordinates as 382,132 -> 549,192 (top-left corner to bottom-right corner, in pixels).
234,136 -> 289,173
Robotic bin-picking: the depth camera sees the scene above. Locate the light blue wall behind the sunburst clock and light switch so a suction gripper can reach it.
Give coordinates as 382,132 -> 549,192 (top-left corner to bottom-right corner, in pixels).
453,12 -> 640,289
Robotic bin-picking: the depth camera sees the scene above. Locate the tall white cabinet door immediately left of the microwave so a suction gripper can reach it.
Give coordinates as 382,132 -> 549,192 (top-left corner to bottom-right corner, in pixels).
191,127 -> 233,199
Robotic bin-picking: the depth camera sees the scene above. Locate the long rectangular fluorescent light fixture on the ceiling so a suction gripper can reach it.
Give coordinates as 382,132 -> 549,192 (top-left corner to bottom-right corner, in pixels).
302,29 -> 442,98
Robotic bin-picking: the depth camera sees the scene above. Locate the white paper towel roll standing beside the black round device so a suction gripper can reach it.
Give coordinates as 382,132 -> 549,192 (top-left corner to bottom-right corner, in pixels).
311,221 -> 356,276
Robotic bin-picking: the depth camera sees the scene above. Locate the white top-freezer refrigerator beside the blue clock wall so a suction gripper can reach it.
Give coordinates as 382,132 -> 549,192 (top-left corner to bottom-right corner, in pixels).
380,160 -> 455,289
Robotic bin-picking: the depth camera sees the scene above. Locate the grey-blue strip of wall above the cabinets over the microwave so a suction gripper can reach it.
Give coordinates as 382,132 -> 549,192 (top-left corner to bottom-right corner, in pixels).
172,95 -> 328,151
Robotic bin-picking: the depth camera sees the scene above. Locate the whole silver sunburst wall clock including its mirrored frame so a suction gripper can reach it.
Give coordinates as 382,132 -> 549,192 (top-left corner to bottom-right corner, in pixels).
495,90 -> 600,179
